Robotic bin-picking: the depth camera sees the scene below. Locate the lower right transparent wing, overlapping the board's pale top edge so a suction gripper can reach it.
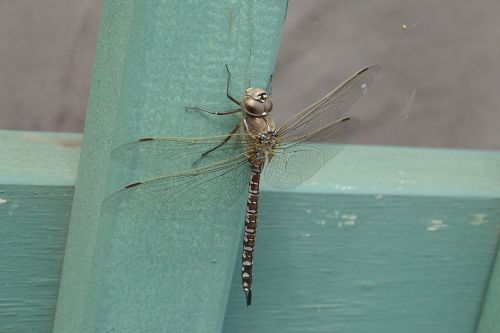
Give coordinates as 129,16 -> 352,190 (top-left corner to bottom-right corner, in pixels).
263,118 -> 360,188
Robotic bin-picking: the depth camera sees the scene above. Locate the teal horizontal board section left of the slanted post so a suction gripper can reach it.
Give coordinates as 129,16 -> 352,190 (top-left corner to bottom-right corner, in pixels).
0,131 -> 81,333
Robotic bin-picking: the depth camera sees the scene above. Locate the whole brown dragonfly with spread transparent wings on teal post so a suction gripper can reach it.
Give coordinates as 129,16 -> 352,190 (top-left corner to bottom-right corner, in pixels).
103,65 -> 379,306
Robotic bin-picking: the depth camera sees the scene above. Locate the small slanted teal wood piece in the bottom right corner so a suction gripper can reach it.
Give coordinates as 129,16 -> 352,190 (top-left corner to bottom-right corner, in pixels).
477,244 -> 500,333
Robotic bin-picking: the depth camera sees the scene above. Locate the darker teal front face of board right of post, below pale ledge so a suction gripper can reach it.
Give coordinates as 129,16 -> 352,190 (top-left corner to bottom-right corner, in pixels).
224,192 -> 500,333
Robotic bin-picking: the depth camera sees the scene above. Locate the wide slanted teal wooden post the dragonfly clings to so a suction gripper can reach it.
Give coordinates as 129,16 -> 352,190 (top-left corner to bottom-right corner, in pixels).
54,0 -> 286,333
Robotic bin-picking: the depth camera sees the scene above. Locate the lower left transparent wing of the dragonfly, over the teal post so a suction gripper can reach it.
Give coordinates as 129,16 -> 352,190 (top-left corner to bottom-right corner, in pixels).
102,155 -> 249,219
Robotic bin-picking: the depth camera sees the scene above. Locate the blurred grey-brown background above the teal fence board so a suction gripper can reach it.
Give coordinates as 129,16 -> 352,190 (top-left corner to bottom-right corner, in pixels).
0,0 -> 500,149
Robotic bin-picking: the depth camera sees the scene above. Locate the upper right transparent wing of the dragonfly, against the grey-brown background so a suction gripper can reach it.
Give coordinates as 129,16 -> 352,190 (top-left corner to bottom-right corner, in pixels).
278,66 -> 380,141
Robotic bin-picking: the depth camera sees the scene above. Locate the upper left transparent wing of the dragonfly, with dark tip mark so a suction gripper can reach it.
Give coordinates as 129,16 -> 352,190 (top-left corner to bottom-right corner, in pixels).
111,133 -> 244,177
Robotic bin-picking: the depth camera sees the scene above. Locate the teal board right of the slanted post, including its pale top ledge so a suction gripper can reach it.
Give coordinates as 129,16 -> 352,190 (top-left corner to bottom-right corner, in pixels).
224,147 -> 500,333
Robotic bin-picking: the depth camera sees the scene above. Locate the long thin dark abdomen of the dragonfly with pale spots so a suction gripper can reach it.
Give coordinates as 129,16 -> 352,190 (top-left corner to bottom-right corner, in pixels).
241,165 -> 262,306
